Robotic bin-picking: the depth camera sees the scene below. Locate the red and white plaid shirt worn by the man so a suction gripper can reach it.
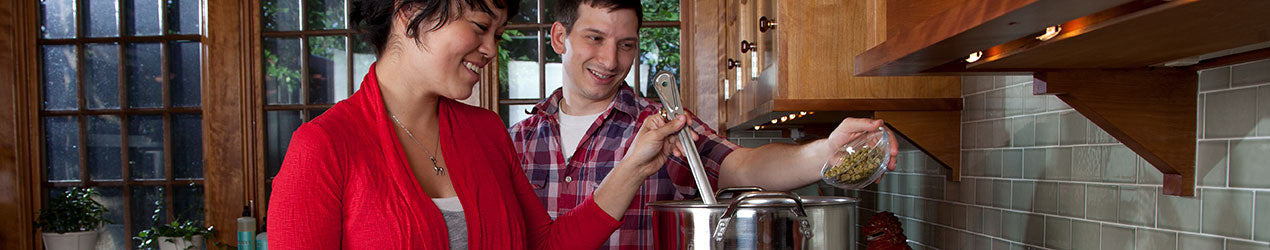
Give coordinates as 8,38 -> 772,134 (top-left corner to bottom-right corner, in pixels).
509,85 -> 740,249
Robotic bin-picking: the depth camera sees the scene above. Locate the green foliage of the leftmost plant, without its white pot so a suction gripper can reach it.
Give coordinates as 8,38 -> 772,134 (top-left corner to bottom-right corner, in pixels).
36,188 -> 112,234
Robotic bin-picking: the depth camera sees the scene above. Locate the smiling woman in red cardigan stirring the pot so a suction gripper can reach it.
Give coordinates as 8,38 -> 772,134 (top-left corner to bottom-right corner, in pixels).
268,0 -> 685,250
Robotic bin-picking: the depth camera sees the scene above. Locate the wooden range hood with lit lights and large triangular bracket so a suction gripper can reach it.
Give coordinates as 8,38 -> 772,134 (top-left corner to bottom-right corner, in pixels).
852,0 -> 1270,195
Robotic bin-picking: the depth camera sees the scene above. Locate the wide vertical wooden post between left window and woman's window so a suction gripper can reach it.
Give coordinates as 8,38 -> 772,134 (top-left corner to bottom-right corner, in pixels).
202,0 -> 250,245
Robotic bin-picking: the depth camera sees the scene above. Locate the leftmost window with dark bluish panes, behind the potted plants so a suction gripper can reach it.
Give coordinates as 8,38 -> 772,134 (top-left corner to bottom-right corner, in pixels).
36,0 -> 203,249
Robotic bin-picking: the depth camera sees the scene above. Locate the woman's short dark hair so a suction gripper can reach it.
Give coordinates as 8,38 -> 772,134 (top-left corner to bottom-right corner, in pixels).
349,0 -> 521,55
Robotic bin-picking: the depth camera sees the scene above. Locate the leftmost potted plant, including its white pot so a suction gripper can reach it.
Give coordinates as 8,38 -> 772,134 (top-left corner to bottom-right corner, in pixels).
36,188 -> 110,250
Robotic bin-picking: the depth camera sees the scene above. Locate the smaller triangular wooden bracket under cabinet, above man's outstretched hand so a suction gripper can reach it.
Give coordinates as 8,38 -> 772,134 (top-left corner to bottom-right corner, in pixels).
874,110 -> 961,181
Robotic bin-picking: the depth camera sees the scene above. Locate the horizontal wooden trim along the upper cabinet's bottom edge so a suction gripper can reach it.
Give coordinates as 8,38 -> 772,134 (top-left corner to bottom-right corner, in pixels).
772,98 -> 961,112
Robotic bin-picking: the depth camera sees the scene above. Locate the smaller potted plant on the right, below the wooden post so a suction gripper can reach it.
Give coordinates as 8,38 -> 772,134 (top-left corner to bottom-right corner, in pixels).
132,221 -> 212,250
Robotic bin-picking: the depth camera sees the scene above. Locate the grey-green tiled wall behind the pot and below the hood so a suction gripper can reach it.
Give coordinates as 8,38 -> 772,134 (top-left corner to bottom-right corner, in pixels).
846,60 -> 1270,250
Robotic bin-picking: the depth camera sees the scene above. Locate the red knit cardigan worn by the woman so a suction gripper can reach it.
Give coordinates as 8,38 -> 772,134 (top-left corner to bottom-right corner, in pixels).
268,66 -> 621,250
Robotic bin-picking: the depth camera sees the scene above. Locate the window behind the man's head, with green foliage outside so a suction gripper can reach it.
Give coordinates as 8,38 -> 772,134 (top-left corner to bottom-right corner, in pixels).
498,0 -> 679,126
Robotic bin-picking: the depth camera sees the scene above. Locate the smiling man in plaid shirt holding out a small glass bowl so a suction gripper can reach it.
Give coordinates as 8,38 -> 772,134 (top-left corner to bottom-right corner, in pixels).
509,0 -> 898,249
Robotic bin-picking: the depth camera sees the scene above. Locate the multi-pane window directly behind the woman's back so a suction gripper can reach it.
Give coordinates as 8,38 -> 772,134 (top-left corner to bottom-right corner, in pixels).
255,0 -> 376,211
